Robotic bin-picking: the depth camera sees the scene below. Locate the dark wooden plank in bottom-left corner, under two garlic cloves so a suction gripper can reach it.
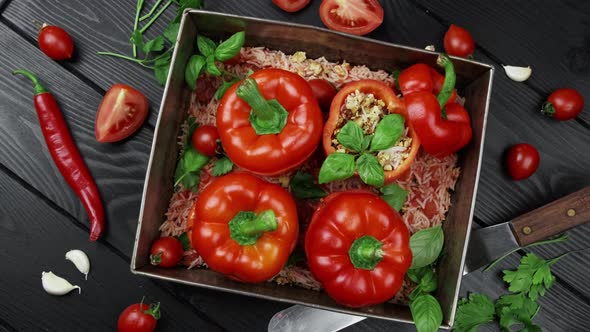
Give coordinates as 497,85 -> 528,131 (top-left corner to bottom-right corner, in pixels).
0,172 -> 221,331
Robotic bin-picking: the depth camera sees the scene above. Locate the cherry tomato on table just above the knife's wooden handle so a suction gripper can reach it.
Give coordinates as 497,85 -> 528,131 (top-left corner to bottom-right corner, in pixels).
506,143 -> 540,181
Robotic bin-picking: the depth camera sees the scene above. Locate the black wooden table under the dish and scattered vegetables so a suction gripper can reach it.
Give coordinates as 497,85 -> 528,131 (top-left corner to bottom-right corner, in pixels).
0,0 -> 590,331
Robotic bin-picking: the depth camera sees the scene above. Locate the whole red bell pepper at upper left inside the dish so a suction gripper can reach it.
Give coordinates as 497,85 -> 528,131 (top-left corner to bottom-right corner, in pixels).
217,69 -> 324,176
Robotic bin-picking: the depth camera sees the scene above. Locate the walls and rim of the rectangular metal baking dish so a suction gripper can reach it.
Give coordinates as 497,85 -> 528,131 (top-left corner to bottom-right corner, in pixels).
131,10 -> 494,328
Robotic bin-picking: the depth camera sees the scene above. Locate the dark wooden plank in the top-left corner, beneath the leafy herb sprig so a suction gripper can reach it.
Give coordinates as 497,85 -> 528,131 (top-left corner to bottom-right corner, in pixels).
3,0 -> 175,125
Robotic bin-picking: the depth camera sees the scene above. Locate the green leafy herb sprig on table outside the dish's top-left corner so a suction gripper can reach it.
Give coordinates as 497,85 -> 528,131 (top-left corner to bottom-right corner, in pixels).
97,0 -> 203,85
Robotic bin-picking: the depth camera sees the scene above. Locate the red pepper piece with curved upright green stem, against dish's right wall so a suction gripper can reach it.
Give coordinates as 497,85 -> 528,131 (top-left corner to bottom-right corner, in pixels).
399,54 -> 472,158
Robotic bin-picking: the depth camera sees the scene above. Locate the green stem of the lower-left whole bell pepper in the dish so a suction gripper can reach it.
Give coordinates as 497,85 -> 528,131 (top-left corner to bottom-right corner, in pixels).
228,210 -> 278,245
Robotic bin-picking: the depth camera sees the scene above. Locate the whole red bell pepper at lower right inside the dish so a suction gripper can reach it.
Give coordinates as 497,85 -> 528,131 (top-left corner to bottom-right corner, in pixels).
305,190 -> 412,307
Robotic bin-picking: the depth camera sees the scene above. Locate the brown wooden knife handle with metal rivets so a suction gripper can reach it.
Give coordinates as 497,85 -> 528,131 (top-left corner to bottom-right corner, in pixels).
512,187 -> 590,246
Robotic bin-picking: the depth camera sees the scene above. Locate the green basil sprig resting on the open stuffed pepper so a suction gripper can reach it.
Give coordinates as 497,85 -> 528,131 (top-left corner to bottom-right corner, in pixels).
319,114 -> 404,187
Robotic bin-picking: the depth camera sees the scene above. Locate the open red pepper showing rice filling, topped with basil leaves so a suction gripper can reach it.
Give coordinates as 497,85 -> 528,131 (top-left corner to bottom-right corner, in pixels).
319,79 -> 420,187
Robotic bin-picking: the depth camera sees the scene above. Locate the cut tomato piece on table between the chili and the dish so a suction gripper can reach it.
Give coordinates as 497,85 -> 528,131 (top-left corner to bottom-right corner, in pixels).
94,84 -> 148,143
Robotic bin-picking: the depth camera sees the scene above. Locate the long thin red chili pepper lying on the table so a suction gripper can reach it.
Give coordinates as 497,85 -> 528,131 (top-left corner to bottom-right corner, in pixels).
13,69 -> 104,241
